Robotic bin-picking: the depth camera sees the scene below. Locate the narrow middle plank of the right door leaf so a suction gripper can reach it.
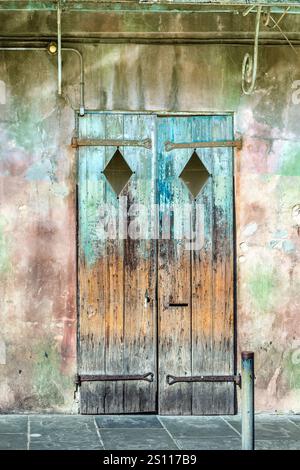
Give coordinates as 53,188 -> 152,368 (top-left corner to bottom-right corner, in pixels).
191,116 -> 214,415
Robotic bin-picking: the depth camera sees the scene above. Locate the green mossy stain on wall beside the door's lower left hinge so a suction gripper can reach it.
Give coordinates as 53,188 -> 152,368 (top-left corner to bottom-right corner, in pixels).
33,340 -> 72,408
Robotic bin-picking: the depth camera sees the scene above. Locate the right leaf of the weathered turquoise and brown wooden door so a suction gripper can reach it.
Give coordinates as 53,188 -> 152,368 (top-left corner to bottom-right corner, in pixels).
158,116 -> 234,414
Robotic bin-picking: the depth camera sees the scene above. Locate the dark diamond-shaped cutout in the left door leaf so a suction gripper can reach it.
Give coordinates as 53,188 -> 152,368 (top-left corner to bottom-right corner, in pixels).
103,149 -> 133,196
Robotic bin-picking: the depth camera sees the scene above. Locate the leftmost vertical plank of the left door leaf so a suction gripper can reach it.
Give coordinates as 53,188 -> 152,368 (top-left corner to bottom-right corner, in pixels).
78,115 -> 106,413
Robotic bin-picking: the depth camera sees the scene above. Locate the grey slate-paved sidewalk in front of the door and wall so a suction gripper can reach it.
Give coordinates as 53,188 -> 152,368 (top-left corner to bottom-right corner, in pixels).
0,415 -> 300,450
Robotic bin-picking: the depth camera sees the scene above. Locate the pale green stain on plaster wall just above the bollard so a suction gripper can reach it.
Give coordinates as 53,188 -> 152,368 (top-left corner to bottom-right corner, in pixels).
248,265 -> 279,313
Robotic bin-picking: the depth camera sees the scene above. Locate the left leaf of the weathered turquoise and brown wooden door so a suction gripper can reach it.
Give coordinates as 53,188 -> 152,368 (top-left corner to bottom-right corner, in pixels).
79,114 -> 157,414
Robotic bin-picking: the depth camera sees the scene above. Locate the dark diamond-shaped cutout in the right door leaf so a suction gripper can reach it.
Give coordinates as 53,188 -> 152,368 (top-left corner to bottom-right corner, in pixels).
179,150 -> 210,197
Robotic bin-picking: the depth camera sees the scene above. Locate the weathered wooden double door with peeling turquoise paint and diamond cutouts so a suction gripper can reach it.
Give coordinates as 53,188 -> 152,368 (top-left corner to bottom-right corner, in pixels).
78,113 -> 234,415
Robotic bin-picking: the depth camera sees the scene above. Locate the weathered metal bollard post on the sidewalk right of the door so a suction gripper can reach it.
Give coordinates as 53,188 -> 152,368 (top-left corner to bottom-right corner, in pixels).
241,351 -> 254,450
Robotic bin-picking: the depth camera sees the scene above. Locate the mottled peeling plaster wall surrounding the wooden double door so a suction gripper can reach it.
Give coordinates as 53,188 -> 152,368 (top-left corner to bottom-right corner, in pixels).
0,14 -> 300,412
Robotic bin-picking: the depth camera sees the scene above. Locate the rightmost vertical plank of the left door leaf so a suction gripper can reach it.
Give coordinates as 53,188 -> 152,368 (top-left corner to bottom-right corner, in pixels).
124,115 -> 157,413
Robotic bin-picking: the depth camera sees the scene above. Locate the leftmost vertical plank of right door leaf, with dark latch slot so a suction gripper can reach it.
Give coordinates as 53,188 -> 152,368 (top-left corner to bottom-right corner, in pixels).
158,118 -> 192,415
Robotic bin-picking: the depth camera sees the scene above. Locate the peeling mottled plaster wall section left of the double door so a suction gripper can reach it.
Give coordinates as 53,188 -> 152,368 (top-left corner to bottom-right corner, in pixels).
0,52 -> 76,412
